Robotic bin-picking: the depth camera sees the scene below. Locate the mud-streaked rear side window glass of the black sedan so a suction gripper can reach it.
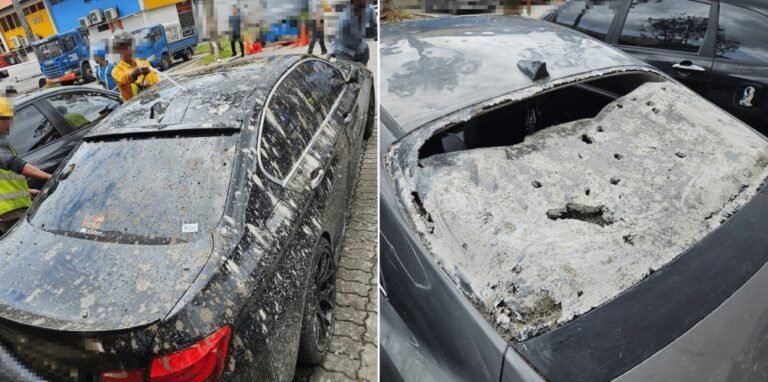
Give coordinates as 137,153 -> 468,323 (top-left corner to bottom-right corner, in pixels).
259,64 -> 325,180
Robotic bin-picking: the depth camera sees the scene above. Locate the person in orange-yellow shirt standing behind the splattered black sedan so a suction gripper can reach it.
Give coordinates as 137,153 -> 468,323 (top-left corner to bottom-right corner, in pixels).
112,32 -> 160,102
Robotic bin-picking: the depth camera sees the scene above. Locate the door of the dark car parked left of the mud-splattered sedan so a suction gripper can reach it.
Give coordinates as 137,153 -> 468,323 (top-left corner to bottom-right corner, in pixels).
20,91 -> 120,182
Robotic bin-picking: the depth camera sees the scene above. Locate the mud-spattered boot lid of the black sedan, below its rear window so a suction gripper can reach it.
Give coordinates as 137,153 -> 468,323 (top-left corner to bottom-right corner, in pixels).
0,222 -> 213,331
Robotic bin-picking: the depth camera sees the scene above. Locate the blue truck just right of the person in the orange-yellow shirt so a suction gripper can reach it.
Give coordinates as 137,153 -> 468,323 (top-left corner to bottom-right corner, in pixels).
131,23 -> 198,70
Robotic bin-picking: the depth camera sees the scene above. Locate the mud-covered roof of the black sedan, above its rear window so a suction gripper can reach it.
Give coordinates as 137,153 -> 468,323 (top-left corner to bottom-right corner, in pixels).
89,55 -> 305,136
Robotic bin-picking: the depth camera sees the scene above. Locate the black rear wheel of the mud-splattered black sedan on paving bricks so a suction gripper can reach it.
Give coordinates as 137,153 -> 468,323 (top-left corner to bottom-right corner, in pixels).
299,238 -> 336,365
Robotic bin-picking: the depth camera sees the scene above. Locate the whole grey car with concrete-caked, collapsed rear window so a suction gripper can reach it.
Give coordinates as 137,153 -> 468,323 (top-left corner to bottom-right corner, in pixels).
380,16 -> 768,381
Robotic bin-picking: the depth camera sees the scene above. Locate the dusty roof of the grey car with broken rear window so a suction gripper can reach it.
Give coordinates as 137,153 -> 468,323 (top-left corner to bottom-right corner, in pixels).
381,15 -> 648,130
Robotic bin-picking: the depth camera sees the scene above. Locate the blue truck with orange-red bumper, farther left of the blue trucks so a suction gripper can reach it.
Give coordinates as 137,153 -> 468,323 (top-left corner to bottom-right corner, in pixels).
32,29 -> 96,87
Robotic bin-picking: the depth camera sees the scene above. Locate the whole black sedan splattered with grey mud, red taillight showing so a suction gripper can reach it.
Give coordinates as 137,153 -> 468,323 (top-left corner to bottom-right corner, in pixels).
0,56 -> 374,381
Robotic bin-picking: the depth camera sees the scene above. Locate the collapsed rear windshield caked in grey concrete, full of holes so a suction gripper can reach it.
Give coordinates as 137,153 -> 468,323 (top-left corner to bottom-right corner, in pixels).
387,73 -> 768,340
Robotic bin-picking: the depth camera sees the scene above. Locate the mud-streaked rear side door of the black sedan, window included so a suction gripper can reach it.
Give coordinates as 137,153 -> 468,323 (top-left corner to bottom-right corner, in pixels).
259,59 -> 349,254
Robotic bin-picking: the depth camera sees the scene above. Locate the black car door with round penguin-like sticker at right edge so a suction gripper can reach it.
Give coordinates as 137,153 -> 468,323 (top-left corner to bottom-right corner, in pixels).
709,3 -> 768,134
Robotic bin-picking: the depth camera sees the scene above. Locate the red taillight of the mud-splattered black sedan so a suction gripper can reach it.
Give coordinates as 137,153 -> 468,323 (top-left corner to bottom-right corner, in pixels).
149,326 -> 232,382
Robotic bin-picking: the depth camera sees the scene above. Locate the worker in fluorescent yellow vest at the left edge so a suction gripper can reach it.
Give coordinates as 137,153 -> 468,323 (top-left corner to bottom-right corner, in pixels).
0,97 -> 51,234
